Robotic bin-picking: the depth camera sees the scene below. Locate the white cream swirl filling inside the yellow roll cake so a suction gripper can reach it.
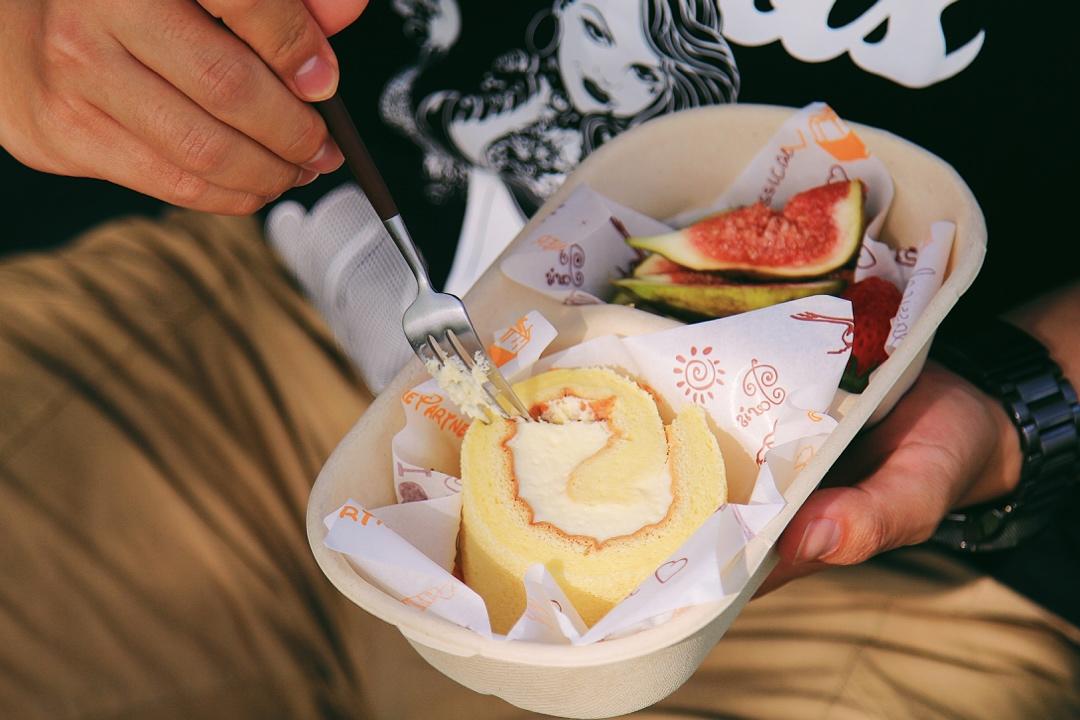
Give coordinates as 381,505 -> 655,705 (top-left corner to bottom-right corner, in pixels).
507,410 -> 673,541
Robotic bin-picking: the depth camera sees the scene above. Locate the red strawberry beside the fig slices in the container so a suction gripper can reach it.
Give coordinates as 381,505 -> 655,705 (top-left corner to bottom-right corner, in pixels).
840,277 -> 902,393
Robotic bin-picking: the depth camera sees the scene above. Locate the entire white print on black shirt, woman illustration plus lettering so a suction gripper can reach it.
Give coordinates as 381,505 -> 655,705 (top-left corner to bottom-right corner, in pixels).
380,0 -> 984,291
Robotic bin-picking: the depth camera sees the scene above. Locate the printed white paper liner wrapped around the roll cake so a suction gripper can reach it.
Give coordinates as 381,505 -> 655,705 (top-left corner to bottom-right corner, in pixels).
326,296 -> 851,644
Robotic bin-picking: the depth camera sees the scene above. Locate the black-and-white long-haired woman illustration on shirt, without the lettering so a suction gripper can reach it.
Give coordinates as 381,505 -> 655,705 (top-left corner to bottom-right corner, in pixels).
382,0 -> 739,202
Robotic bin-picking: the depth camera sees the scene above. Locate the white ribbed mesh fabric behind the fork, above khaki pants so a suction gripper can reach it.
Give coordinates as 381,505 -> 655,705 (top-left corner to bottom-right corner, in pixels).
266,185 -> 416,393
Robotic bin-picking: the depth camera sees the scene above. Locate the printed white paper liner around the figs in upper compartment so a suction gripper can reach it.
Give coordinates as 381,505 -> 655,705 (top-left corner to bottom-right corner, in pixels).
500,103 -> 955,388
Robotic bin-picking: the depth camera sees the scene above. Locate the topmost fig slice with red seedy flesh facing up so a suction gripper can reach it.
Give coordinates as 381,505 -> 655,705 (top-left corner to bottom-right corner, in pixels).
626,180 -> 865,277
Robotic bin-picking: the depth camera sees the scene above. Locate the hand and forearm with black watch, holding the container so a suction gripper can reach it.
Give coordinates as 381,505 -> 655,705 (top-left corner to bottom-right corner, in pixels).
758,283 -> 1080,595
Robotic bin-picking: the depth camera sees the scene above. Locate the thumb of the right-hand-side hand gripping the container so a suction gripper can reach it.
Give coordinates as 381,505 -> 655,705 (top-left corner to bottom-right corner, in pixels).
759,446 -> 956,594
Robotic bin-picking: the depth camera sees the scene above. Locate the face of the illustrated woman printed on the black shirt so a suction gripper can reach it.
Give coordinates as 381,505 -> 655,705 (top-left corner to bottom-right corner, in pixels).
558,0 -> 666,118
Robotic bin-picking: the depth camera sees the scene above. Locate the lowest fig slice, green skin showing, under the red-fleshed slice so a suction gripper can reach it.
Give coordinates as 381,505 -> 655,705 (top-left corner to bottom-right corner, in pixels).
615,271 -> 847,317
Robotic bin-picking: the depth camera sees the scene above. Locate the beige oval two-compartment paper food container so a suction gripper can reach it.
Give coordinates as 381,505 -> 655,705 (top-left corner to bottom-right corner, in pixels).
308,105 -> 986,718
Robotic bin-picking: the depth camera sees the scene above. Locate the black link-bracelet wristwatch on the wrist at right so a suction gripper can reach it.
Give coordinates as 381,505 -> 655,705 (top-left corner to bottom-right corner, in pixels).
930,320 -> 1080,553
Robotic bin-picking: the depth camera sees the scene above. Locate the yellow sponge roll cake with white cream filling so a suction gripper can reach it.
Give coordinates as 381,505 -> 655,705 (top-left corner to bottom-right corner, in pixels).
460,368 -> 727,633
